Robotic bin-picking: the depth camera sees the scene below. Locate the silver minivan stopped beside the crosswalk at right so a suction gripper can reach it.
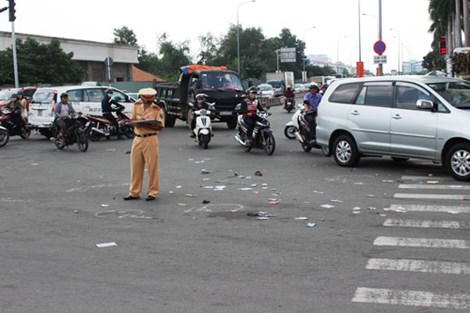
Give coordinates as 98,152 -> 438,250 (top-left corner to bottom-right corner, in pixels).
316,76 -> 470,181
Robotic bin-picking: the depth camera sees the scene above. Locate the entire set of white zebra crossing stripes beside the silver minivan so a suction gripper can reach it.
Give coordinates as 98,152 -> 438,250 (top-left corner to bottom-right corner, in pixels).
351,176 -> 470,311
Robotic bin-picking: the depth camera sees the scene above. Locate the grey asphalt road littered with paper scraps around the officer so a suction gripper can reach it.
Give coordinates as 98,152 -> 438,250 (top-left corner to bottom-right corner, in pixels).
0,103 -> 470,313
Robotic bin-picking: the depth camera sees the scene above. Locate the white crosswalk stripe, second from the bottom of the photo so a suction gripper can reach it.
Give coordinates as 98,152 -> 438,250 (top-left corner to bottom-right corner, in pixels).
366,258 -> 470,275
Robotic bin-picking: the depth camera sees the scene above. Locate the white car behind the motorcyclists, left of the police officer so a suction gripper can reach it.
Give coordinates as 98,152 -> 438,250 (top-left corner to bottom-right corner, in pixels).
28,86 -> 134,138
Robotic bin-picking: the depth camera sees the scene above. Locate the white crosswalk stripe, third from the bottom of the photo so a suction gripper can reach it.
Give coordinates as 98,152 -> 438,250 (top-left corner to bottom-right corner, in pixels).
374,236 -> 470,249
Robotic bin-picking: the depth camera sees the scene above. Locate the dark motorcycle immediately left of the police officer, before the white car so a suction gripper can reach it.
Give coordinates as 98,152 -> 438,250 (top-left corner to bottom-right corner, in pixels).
87,106 -> 134,141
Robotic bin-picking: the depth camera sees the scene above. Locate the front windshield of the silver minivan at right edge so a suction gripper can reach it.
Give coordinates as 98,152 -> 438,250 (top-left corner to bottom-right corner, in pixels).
428,81 -> 470,110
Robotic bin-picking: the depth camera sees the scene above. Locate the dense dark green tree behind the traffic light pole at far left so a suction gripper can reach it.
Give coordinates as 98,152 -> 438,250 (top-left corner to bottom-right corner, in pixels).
0,37 -> 85,85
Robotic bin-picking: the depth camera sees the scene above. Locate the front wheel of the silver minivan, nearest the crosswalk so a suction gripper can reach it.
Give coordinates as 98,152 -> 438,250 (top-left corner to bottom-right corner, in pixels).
445,143 -> 470,181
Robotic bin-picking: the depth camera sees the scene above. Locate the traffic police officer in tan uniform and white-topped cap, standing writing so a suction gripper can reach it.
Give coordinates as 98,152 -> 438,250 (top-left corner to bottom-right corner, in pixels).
124,88 -> 164,201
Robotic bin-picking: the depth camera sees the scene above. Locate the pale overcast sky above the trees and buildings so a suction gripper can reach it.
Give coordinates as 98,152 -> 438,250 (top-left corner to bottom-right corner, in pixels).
0,0 -> 432,72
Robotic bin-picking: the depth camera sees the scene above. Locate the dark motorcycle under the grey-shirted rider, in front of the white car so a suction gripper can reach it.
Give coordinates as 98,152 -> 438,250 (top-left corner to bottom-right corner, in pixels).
52,113 -> 89,152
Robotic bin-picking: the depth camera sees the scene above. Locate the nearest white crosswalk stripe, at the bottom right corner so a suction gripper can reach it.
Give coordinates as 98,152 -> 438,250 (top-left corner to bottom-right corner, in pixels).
351,287 -> 470,310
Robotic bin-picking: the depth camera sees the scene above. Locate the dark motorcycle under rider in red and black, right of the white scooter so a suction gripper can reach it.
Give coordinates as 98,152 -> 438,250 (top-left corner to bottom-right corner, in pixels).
235,106 -> 276,155
